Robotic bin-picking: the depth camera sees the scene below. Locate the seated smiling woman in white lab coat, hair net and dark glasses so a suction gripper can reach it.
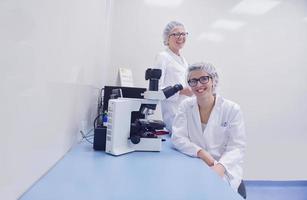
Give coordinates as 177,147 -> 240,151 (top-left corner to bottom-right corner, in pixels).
172,63 -> 246,195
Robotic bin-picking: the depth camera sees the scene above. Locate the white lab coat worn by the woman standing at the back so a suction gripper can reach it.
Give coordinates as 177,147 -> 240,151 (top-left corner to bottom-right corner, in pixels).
154,48 -> 188,131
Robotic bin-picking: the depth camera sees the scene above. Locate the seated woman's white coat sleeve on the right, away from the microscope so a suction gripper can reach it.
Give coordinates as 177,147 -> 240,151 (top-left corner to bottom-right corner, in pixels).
218,105 -> 246,177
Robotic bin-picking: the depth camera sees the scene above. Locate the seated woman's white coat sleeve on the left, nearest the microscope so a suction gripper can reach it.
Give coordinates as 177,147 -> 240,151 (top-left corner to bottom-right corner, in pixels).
171,102 -> 201,157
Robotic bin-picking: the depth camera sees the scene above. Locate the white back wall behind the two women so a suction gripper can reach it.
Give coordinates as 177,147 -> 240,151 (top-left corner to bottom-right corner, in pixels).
108,0 -> 307,180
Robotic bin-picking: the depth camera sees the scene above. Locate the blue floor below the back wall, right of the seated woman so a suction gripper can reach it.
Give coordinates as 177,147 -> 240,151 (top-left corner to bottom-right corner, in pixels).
244,181 -> 307,200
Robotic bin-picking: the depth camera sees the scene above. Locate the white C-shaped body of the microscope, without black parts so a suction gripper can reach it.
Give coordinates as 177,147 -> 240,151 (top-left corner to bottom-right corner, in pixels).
106,98 -> 161,155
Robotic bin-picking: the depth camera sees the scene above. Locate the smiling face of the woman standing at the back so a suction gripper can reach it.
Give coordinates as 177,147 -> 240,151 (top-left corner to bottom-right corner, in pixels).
168,26 -> 186,54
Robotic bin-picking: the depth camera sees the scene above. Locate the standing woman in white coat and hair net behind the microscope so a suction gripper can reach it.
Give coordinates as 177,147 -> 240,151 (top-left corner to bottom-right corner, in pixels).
154,21 -> 192,132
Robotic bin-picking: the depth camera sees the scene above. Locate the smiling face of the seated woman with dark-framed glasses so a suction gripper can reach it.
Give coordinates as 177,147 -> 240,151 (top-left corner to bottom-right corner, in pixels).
188,70 -> 213,98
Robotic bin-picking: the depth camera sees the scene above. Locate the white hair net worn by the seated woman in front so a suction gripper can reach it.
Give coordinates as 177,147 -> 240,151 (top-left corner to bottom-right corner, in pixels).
187,62 -> 219,94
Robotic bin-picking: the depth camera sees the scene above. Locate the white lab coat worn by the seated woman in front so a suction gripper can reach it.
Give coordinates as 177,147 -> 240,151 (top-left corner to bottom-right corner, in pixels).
172,95 -> 246,191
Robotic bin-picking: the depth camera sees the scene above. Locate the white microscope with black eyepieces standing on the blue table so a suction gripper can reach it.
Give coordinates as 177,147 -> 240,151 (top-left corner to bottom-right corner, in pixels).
105,68 -> 183,156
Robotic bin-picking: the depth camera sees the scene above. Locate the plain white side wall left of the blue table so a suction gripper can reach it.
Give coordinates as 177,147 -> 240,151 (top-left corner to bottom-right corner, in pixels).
0,0 -> 109,200
